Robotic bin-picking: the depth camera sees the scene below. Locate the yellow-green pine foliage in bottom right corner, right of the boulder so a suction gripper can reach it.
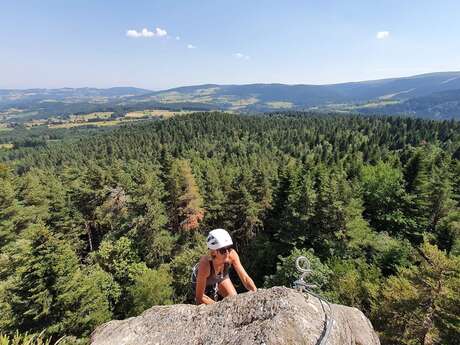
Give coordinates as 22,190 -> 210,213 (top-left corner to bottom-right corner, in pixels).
375,242 -> 460,345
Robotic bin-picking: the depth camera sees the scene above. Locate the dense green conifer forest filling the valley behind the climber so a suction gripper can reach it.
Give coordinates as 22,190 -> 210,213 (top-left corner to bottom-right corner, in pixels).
0,112 -> 460,345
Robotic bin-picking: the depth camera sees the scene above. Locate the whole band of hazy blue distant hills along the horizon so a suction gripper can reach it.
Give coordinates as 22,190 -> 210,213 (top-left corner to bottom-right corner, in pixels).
0,72 -> 460,120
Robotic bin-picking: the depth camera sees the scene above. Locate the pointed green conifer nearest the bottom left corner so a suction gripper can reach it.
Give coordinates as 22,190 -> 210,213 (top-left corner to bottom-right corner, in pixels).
7,224 -> 78,333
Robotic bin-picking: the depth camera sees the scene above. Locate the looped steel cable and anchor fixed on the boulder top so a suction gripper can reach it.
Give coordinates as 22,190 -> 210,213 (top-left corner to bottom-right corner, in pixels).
293,256 -> 335,345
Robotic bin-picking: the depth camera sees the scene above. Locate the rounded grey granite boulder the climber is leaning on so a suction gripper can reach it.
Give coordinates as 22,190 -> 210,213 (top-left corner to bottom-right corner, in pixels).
91,287 -> 380,345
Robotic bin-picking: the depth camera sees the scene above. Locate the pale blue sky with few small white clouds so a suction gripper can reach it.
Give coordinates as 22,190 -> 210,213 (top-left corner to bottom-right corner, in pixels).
0,0 -> 460,90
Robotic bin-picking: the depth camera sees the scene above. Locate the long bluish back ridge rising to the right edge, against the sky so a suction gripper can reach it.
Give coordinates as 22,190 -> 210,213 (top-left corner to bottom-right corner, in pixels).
149,72 -> 460,101
